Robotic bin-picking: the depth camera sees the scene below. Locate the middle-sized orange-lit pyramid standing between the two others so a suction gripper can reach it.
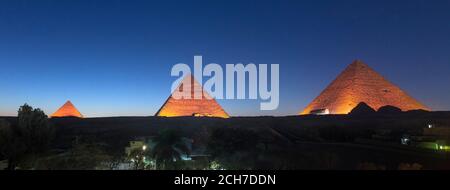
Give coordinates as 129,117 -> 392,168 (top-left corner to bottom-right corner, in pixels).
156,75 -> 230,118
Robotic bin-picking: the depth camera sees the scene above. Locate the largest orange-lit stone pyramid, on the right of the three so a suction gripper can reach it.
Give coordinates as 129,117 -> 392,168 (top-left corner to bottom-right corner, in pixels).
300,60 -> 429,115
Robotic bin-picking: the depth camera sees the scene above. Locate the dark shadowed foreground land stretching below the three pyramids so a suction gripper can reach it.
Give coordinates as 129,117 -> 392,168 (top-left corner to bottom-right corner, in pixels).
0,111 -> 450,170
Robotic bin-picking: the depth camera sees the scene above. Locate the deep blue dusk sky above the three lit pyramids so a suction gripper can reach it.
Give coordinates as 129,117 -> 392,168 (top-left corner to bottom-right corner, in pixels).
0,0 -> 450,117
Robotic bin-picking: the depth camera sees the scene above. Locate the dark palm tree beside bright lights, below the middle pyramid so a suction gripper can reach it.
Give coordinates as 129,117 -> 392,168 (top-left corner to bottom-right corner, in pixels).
152,130 -> 190,169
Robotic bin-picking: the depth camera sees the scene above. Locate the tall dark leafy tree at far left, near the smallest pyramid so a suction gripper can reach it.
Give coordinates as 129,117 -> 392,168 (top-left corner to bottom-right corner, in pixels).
0,104 -> 54,170
